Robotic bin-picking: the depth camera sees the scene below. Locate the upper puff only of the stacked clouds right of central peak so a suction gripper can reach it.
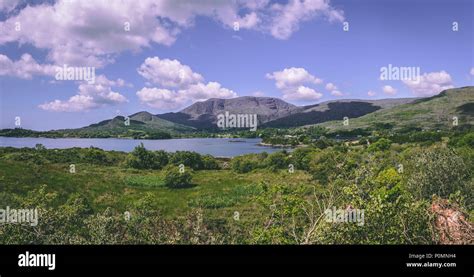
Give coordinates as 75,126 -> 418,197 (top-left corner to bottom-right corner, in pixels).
266,67 -> 322,90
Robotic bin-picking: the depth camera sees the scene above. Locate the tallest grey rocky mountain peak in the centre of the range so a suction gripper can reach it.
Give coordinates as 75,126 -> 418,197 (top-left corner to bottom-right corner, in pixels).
157,96 -> 303,129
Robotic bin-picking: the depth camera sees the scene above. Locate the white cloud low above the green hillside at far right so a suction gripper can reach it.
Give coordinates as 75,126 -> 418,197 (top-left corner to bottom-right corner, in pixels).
403,71 -> 454,96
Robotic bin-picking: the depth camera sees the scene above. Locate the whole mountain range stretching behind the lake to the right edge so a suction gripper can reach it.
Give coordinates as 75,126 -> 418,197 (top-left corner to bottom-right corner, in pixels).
60,87 -> 474,134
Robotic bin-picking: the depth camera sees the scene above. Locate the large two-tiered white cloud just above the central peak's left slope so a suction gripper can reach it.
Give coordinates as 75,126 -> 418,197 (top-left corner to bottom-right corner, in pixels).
137,57 -> 237,110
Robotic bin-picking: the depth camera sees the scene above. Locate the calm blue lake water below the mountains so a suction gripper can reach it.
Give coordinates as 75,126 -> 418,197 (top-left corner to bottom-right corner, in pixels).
0,137 -> 288,157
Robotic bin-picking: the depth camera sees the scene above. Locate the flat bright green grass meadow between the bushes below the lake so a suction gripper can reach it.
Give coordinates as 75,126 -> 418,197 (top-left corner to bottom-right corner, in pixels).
0,159 -> 312,219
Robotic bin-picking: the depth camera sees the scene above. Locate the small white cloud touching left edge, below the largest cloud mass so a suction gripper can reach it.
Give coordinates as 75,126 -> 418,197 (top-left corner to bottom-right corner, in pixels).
0,53 -> 56,79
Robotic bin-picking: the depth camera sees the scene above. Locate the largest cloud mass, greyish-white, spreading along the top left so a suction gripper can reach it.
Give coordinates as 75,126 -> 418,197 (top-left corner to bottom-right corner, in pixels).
0,0 -> 343,67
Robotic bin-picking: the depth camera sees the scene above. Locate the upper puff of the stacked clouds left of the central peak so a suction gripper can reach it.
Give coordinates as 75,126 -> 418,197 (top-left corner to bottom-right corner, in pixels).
138,57 -> 204,88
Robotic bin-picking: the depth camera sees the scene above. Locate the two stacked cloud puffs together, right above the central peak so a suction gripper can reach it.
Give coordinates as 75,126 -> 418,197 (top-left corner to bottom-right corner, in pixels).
266,67 -> 323,101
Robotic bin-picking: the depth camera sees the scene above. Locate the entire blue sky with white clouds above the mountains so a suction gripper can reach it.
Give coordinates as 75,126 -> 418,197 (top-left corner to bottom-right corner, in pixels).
0,0 -> 474,130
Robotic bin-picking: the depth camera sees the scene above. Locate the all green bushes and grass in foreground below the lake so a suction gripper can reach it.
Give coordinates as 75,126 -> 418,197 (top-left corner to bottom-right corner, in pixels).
0,128 -> 474,244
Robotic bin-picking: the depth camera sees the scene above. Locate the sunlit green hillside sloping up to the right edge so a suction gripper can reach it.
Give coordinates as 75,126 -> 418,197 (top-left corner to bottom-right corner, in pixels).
320,86 -> 474,131
